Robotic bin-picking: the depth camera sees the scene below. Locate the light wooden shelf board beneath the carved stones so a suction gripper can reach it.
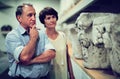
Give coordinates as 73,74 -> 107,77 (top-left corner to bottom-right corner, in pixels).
69,42 -> 116,79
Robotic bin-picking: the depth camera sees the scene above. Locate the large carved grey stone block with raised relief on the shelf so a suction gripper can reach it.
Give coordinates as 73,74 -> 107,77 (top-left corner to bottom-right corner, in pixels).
76,13 -> 112,68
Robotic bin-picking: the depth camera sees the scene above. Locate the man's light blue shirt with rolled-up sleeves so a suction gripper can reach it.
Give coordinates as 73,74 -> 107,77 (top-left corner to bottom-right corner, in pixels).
5,26 -> 54,78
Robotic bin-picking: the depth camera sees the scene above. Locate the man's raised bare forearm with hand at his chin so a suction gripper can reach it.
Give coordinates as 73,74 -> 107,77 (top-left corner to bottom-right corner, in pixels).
19,26 -> 38,63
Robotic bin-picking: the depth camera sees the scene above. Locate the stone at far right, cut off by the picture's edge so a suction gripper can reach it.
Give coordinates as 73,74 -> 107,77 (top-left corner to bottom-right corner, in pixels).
110,14 -> 120,78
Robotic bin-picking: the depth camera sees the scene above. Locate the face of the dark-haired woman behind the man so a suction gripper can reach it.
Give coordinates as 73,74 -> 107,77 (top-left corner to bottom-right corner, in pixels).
44,15 -> 57,28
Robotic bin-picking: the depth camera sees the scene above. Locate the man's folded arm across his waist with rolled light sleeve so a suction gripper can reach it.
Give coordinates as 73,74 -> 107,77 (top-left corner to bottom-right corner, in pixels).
19,28 -> 55,65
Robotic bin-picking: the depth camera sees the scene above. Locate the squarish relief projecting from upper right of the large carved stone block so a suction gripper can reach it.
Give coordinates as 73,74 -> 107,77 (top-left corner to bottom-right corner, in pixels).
92,16 -> 114,48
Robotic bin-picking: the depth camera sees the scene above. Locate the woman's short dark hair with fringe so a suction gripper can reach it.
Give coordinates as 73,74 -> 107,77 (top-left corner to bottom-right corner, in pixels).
39,7 -> 58,24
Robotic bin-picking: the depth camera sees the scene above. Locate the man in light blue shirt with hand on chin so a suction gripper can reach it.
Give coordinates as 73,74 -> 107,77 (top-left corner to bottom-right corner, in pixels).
6,4 -> 55,79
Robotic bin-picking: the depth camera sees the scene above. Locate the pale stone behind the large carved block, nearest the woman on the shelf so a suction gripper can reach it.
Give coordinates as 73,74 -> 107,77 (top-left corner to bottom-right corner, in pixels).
63,24 -> 82,59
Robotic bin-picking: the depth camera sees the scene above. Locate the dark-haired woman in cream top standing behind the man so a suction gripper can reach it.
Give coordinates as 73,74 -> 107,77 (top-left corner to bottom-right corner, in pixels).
39,7 -> 74,79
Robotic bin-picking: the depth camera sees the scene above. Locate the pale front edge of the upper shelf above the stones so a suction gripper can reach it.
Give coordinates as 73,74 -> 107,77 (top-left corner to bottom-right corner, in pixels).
59,0 -> 94,24
